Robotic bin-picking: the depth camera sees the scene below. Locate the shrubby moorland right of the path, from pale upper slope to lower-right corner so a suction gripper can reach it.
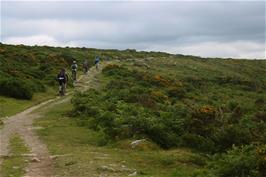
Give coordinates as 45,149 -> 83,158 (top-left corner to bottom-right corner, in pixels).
70,56 -> 266,177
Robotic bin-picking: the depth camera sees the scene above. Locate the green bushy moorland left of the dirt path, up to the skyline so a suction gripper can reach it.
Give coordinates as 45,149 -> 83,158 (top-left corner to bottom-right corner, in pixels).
0,43 -> 167,117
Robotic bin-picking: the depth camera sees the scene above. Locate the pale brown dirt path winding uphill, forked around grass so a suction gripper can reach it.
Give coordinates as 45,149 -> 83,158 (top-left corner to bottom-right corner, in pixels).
0,63 -> 106,177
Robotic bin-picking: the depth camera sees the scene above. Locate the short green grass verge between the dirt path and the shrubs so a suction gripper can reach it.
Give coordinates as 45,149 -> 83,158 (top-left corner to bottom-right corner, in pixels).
35,102 -> 208,177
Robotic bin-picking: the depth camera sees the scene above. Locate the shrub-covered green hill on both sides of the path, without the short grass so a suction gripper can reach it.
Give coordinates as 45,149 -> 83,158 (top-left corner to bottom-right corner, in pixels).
0,44 -> 266,177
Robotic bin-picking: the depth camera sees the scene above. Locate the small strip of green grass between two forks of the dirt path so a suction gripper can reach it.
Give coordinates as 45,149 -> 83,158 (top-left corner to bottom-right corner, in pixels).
0,135 -> 29,177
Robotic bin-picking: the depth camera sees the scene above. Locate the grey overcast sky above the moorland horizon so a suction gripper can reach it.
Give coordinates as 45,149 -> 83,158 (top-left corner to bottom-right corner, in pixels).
1,0 -> 266,59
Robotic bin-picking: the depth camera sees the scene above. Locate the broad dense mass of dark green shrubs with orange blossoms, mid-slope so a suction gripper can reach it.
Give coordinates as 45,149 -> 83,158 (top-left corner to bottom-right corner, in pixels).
69,65 -> 265,153
